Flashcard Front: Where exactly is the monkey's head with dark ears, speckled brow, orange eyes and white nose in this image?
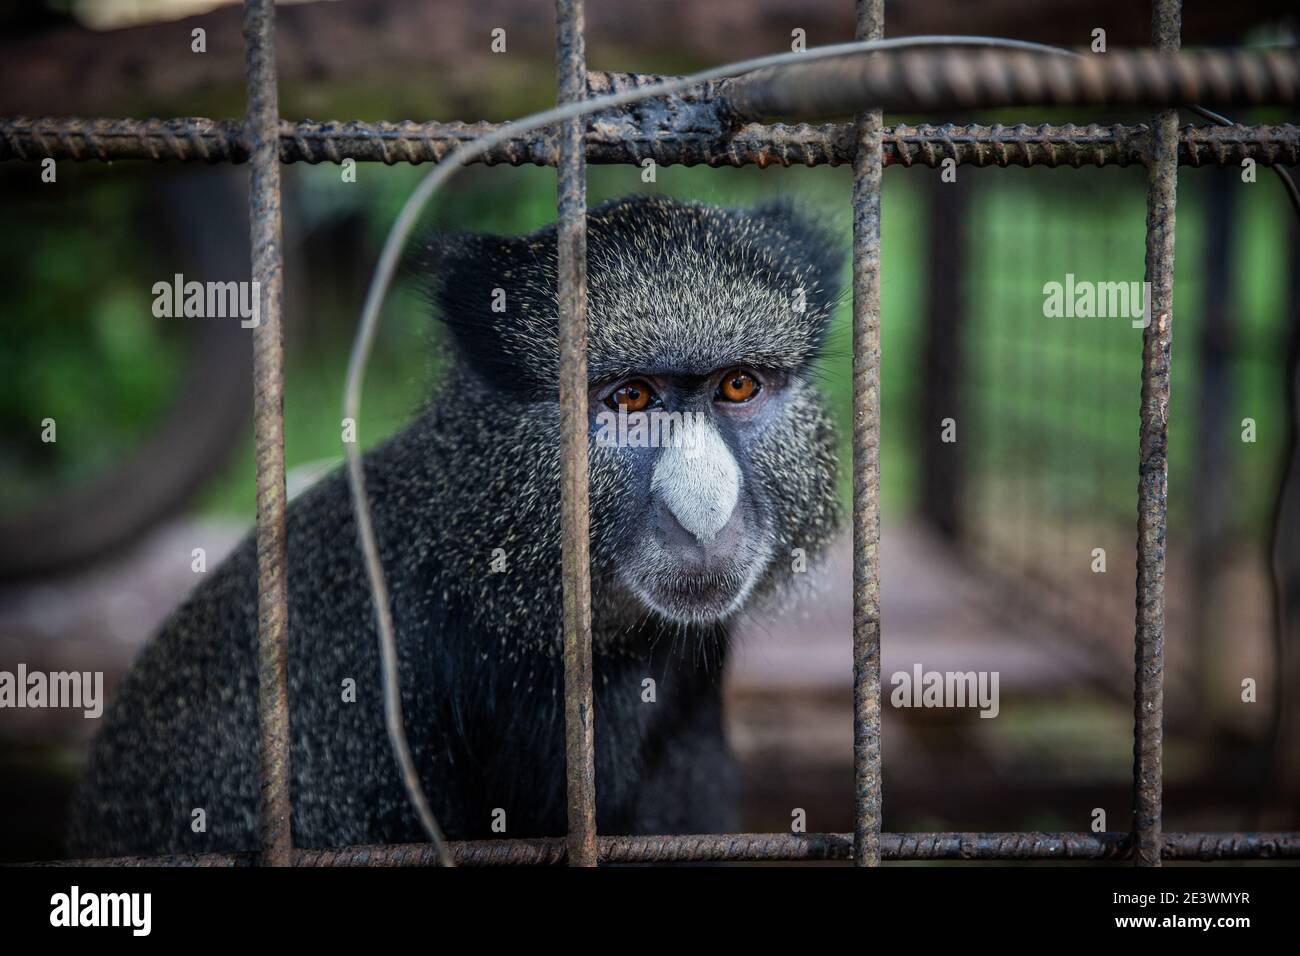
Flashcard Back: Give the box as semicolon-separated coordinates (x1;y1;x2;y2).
432;196;842;623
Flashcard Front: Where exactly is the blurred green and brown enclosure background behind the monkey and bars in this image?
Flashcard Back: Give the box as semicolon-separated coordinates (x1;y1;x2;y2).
0;0;1300;861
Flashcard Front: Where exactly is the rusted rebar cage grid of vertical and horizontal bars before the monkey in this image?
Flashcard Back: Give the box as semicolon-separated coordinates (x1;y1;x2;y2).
10;0;1300;866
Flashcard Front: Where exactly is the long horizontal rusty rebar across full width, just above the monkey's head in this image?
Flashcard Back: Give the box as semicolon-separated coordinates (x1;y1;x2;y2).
0;115;1300;168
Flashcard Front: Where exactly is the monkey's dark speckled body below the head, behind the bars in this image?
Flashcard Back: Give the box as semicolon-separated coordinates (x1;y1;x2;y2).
73;395;731;856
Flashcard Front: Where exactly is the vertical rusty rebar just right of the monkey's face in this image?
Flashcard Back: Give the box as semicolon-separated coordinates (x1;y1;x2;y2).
853;0;884;866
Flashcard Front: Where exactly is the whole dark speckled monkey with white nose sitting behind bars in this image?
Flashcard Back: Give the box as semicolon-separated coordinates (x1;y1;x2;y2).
68;195;844;858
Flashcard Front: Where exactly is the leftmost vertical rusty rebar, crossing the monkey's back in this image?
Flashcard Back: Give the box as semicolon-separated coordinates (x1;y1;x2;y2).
243;0;293;866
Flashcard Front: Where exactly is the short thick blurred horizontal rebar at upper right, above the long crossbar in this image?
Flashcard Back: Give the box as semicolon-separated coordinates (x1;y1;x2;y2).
723;46;1300;120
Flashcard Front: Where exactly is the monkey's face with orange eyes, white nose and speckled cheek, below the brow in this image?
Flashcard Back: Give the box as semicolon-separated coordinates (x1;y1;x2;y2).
589;364;835;623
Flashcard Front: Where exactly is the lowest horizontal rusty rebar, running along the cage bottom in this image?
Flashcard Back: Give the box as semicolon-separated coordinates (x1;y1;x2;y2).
38;832;1300;866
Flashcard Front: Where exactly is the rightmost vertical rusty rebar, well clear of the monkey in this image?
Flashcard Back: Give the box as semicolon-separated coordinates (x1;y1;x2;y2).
1134;0;1182;866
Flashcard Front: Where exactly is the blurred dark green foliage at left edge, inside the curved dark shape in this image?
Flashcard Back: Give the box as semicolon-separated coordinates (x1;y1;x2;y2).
0;174;181;511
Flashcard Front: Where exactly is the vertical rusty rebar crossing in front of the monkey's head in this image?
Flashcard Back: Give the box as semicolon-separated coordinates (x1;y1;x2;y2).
555;0;595;866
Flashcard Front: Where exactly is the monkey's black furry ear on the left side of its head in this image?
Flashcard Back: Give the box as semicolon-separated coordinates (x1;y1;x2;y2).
415;228;556;393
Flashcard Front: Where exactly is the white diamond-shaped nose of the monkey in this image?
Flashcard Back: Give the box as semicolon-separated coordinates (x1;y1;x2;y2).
650;414;740;544
